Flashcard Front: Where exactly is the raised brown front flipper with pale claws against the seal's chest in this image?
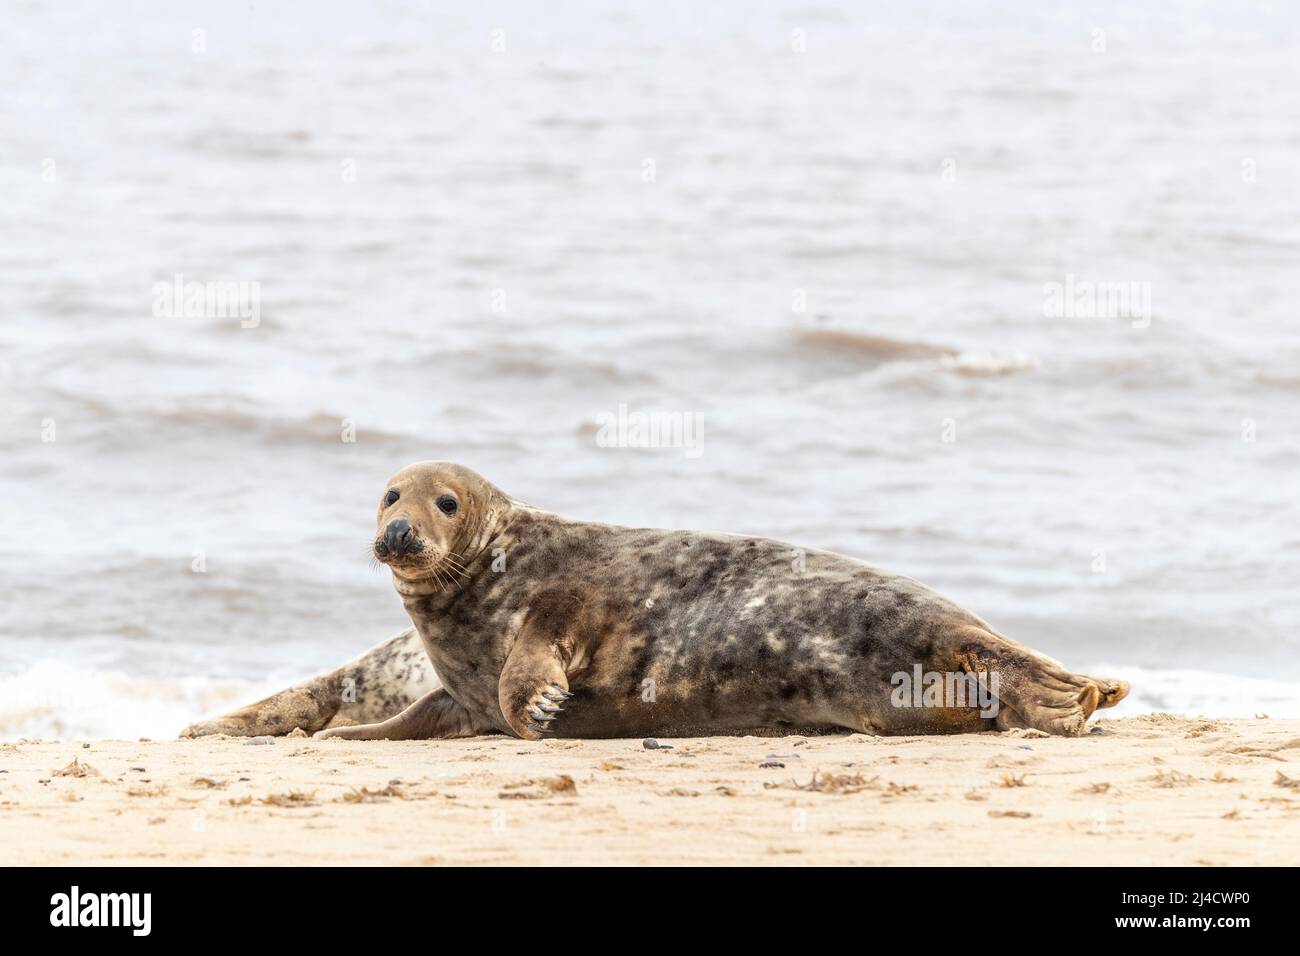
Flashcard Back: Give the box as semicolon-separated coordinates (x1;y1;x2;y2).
497;592;582;740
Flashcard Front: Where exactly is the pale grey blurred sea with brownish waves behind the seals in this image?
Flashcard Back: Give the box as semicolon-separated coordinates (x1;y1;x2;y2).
0;0;1300;739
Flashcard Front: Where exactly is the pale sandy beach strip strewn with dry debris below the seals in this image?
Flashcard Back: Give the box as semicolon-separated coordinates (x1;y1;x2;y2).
0;714;1300;866
